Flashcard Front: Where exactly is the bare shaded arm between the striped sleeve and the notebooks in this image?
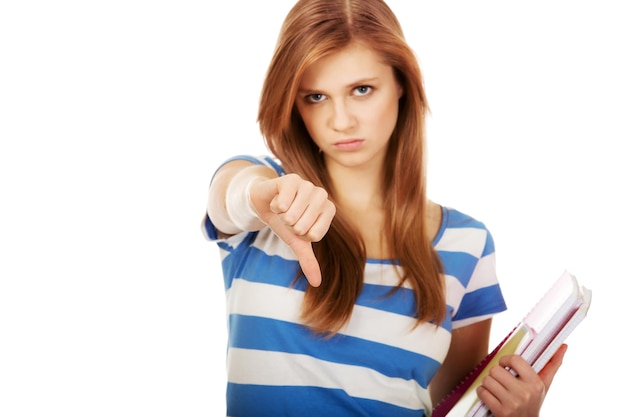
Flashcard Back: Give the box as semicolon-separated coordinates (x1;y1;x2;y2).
430;319;491;405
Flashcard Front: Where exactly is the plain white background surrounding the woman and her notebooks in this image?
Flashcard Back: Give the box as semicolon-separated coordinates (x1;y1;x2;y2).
0;0;626;417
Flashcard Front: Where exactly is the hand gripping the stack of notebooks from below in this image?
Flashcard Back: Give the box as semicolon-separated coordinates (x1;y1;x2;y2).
476;344;567;417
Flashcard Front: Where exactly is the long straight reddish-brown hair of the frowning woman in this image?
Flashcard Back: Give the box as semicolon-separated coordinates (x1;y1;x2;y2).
258;0;445;334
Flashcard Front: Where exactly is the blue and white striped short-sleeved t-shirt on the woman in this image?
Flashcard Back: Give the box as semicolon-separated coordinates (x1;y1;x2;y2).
203;157;506;417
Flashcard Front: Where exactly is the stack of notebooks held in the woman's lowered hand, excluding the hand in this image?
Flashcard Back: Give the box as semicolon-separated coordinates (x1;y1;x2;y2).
431;271;591;417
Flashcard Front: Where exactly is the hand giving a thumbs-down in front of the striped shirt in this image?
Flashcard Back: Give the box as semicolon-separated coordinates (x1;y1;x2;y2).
250;174;336;287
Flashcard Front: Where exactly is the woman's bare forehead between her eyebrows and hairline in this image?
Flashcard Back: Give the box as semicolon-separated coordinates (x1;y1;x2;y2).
300;42;393;89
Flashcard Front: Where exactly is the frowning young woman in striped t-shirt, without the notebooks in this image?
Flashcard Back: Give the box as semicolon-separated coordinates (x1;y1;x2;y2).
203;0;565;417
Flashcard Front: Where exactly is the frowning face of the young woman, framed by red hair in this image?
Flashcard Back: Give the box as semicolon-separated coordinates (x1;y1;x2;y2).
296;43;403;169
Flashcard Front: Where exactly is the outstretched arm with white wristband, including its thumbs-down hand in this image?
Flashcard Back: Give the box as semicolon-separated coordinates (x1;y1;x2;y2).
207;161;335;287
